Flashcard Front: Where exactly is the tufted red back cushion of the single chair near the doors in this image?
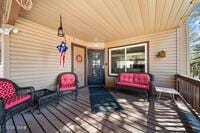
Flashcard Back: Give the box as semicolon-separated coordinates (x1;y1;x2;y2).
60;74;76;87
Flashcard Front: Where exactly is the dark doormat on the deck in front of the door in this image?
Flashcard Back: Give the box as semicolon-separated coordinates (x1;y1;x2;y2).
89;87;123;113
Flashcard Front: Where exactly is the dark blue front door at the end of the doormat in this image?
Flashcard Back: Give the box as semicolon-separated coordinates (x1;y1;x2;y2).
88;49;105;85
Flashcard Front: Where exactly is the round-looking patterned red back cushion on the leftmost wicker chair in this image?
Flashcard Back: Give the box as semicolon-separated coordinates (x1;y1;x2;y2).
0;81;15;100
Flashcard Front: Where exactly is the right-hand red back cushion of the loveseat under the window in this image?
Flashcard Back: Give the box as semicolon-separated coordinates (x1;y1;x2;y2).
133;74;150;85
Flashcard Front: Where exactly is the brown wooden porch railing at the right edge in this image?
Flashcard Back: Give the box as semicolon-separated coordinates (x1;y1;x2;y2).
176;75;200;116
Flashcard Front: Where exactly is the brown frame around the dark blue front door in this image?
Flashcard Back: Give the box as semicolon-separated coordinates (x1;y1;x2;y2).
87;48;106;86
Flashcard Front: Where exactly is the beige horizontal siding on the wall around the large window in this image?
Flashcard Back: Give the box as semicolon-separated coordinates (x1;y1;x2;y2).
105;30;177;87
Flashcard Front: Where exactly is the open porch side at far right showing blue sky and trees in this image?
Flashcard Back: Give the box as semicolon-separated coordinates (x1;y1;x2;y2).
188;4;200;79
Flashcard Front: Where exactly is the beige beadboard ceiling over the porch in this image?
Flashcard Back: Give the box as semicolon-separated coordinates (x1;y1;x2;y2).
20;0;192;42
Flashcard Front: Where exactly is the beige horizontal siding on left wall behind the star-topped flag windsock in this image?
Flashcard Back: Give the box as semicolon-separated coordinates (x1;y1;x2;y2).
9;18;87;90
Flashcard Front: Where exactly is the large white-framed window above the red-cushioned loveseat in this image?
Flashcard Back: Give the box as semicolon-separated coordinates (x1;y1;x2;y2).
108;42;148;76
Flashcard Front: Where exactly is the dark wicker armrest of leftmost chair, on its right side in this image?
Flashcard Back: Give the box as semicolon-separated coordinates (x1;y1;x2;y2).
17;86;35;99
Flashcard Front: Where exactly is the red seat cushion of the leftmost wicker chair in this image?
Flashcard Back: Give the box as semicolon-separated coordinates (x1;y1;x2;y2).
5;95;31;110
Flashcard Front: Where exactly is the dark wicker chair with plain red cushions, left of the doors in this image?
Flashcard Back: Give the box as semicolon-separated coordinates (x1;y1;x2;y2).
56;72;79;100
